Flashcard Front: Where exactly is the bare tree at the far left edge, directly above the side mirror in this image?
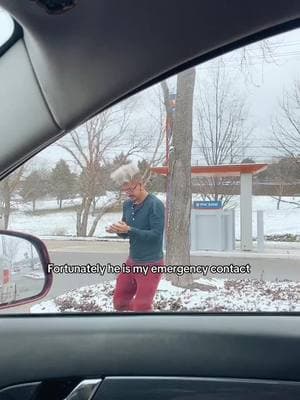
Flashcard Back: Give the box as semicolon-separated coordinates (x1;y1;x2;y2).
0;165;25;229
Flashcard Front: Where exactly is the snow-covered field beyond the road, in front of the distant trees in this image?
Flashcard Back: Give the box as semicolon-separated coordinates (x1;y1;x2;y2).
9;192;300;239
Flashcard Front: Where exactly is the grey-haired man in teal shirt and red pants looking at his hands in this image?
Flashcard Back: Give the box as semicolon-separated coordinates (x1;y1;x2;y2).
106;164;165;312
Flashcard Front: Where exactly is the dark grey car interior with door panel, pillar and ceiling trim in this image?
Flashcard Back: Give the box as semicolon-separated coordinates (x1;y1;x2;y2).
0;0;300;400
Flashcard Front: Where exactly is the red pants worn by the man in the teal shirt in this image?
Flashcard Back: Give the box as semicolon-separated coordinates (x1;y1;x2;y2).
113;257;164;312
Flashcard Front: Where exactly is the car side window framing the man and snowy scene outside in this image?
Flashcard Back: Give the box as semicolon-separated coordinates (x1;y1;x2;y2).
0;26;300;313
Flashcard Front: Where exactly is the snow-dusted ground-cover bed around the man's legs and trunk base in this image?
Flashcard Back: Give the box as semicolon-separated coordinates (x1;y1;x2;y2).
31;278;300;313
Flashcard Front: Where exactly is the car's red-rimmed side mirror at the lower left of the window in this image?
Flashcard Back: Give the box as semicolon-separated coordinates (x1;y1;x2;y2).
0;230;53;310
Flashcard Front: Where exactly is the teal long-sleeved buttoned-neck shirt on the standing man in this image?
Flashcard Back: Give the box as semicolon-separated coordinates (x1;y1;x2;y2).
119;193;165;262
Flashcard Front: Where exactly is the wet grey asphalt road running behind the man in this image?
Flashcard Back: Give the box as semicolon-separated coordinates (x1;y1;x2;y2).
2;241;300;313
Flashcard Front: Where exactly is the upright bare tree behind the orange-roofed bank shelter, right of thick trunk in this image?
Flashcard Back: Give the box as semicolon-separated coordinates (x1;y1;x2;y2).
194;58;251;204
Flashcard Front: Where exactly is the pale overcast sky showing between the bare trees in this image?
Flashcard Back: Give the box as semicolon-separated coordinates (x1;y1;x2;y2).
0;7;300;167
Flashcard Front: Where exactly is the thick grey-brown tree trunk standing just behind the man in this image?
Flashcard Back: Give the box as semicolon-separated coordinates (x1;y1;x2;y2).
166;68;196;287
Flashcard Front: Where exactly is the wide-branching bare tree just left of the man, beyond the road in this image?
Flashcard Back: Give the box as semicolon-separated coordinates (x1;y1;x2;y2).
58;102;142;236
